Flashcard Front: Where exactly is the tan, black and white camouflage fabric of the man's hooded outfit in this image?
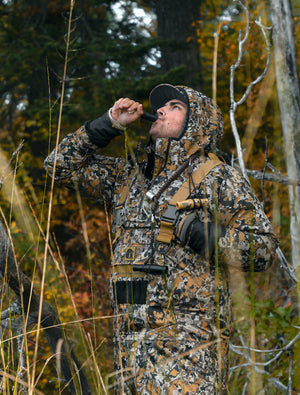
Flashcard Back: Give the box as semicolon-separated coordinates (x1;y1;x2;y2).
46;87;277;395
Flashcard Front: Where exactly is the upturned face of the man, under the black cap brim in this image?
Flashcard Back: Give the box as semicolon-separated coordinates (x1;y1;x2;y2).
149;99;187;141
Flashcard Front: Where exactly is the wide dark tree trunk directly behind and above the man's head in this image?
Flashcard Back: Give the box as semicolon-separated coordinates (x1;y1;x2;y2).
154;0;202;89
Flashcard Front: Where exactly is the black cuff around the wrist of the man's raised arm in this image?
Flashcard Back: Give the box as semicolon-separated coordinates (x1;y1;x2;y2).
84;113;122;148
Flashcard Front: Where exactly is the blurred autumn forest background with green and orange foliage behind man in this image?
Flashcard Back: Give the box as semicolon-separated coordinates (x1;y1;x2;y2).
0;0;300;394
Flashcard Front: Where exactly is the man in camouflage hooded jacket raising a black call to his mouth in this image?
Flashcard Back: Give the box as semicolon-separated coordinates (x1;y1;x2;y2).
45;84;277;395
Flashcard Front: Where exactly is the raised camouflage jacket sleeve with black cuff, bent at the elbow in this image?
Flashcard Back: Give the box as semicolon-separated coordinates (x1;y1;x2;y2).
44;114;124;203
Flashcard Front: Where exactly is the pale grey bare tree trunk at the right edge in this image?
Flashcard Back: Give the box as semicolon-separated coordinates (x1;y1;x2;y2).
271;0;300;269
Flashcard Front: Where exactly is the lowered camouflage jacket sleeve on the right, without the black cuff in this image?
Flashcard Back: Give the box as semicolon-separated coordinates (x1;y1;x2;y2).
217;168;278;272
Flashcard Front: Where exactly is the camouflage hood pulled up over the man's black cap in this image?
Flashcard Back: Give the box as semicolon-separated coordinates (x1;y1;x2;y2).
151;86;224;170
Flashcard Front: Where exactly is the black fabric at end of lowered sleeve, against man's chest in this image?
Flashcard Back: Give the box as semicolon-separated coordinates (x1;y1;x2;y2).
180;217;226;258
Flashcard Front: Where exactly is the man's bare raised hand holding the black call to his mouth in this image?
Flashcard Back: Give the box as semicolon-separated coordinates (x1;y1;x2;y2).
111;97;143;126
